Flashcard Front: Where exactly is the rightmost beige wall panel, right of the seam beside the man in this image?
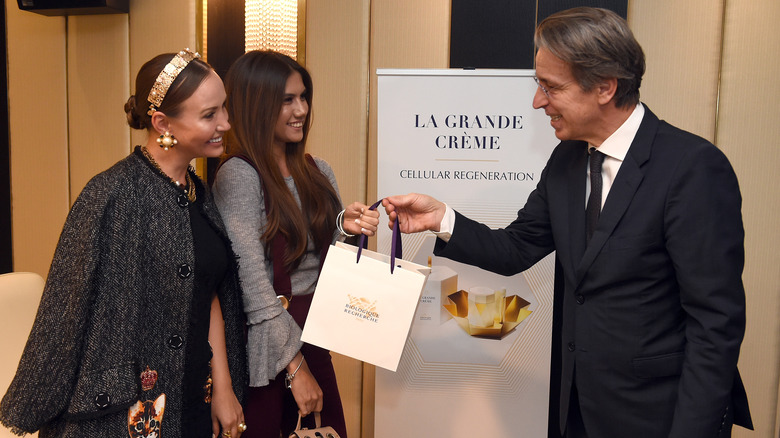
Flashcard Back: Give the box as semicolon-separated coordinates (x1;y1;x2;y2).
716;0;780;438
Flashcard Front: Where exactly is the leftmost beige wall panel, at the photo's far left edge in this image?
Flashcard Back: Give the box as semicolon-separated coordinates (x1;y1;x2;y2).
5;2;70;277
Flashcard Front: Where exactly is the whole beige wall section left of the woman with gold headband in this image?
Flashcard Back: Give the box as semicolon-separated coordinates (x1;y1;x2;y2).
5;0;201;277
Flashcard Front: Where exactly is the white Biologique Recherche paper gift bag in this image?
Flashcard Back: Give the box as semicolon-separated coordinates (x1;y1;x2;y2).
301;207;430;371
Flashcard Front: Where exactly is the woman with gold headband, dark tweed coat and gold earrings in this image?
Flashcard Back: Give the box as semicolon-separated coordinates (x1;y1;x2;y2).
0;50;247;438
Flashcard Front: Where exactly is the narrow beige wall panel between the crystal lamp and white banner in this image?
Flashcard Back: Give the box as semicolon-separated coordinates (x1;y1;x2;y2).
305;0;373;437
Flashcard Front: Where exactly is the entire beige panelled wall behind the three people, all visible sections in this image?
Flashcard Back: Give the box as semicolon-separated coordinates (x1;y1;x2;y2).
6;0;780;438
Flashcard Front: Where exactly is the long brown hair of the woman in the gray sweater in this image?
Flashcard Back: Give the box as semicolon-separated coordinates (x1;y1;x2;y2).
225;51;341;269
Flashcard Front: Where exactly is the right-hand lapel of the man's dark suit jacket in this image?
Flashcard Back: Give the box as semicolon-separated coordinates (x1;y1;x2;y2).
572;107;658;286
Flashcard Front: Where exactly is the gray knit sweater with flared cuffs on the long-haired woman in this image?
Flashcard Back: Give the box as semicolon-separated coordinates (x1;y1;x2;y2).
212;158;339;386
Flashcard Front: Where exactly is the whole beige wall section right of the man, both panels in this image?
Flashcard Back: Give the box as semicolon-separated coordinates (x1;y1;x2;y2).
629;0;780;438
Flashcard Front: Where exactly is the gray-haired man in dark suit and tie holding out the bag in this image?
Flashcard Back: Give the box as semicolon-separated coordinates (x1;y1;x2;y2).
385;8;752;438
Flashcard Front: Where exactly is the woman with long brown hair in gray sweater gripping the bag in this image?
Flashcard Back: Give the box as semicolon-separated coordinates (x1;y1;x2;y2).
213;51;379;438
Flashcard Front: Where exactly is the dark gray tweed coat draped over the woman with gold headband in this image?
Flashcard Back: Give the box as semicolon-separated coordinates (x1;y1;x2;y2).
0;147;248;438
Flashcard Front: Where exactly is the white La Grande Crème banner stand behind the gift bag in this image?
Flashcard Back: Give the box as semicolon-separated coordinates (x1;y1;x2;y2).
375;70;558;438
